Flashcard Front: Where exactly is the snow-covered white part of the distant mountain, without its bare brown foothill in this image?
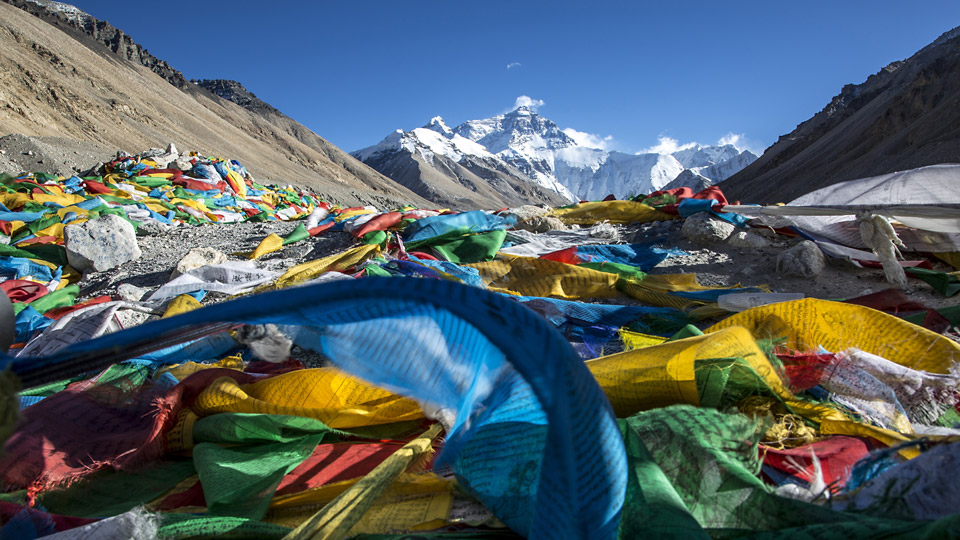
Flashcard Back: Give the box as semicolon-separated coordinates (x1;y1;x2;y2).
353;106;757;206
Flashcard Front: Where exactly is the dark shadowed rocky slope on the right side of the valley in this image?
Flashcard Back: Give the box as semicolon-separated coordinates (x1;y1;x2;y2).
722;27;960;203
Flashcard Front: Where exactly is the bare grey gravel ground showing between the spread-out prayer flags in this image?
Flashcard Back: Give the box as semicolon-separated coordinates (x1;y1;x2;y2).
71;215;956;318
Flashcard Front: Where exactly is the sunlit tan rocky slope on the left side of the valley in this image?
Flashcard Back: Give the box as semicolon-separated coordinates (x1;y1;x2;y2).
0;0;432;206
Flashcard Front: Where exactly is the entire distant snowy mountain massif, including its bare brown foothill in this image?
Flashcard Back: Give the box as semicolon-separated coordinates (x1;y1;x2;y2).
351;106;757;209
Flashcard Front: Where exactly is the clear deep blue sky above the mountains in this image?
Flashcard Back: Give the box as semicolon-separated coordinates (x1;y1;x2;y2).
75;0;960;156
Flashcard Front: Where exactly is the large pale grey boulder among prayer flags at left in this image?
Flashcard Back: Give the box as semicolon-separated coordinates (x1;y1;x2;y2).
63;214;141;272
